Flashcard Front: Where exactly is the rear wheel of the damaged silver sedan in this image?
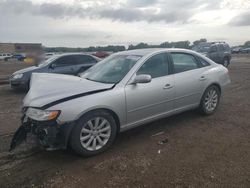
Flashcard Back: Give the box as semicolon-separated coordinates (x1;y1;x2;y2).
199;85;220;115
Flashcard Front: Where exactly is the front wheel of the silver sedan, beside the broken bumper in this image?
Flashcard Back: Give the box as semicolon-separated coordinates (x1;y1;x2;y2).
70;110;117;156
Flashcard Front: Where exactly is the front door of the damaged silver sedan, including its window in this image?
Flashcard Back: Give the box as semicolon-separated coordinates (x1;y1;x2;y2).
125;53;174;124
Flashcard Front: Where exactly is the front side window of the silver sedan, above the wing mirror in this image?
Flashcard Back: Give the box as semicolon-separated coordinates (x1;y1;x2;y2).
136;53;169;78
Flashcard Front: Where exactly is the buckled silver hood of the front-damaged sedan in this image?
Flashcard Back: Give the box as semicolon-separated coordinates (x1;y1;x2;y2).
23;73;114;107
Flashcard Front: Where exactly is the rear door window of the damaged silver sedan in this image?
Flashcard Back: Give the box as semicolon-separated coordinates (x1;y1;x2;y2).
171;53;200;73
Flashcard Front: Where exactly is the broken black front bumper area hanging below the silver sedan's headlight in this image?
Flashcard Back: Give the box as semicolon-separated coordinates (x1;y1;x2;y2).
10;115;74;151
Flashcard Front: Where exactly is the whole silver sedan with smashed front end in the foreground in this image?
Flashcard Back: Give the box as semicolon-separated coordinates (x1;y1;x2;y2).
10;49;230;156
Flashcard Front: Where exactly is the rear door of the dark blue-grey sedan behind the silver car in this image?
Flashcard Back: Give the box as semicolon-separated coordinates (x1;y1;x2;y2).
74;55;97;75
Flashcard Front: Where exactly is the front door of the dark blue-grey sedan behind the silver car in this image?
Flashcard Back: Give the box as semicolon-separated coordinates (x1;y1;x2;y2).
49;55;76;75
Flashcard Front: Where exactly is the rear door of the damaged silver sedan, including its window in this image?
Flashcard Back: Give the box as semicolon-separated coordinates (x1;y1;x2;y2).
170;52;210;110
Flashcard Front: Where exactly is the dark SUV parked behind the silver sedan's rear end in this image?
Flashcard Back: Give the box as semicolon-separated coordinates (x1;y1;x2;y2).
192;42;231;67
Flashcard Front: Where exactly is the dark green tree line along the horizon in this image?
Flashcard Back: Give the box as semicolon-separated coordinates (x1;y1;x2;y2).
44;38;250;52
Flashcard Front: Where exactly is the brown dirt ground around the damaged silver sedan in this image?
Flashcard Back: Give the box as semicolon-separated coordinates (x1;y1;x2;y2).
0;56;250;188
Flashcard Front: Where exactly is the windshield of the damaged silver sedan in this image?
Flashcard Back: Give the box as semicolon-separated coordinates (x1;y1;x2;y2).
81;55;141;84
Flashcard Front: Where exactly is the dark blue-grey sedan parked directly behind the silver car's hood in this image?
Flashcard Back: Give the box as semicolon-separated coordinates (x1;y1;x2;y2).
10;53;100;89
